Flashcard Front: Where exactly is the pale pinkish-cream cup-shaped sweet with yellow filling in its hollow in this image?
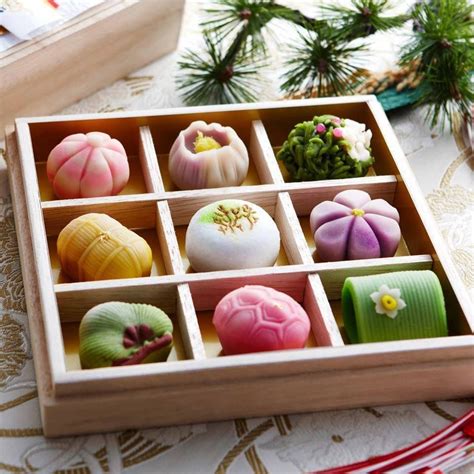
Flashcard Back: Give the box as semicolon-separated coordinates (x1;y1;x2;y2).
168;120;249;189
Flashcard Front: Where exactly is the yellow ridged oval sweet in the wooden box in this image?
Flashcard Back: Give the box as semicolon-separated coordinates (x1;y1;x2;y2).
57;213;152;281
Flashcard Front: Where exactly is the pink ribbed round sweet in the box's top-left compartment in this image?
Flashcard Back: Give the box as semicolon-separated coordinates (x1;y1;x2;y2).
46;132;130;199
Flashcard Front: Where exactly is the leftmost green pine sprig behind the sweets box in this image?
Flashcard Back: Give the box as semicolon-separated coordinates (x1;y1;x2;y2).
177;0;282;105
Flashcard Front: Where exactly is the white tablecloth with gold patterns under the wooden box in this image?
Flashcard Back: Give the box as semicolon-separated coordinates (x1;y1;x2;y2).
0;1;474;474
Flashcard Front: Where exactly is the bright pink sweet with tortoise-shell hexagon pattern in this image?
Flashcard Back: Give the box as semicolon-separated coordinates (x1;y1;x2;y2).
212;285;310;355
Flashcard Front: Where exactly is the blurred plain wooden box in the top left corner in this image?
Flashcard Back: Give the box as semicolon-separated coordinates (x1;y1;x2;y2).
0;0;184;129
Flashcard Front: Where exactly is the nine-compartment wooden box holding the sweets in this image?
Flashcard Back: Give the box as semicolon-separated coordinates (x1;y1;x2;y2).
7;96;474;436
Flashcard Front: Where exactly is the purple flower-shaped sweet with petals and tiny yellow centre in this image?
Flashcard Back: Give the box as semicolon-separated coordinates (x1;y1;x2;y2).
310;189;401;262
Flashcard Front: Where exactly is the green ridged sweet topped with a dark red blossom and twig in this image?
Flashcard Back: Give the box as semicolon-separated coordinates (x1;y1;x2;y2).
79;301;173;369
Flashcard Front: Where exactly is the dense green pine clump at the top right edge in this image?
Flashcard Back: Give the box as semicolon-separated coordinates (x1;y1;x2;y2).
401;0;474;127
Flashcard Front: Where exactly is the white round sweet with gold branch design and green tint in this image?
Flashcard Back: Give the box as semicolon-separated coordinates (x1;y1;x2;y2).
186;199;280;272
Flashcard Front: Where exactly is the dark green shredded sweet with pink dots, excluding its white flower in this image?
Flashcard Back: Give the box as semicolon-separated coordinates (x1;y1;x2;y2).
277;115;375;181
